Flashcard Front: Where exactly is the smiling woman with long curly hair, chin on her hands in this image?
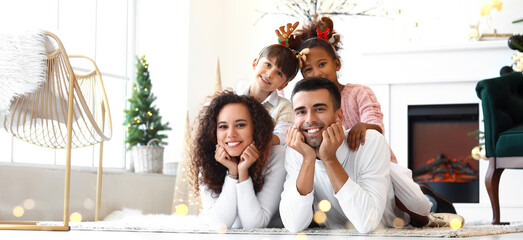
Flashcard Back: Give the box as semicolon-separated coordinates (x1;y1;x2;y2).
189;91;285;228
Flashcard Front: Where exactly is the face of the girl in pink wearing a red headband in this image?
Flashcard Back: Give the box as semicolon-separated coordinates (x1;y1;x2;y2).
301;47;341;83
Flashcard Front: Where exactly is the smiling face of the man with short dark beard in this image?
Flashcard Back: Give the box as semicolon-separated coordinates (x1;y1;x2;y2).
292;89;342;148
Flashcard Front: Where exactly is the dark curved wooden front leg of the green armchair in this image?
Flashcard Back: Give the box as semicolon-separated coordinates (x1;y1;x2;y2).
485;157;505;225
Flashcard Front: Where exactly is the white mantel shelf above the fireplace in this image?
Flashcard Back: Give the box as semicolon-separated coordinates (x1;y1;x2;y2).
341;40;514;85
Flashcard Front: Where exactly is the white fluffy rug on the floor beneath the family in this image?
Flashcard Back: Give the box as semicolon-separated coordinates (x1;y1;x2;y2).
40;209;523;238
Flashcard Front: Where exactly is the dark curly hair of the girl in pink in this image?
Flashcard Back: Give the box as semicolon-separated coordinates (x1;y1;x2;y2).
289;17;341;62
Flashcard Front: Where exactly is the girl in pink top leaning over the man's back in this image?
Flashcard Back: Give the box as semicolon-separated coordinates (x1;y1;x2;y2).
294;17;461;226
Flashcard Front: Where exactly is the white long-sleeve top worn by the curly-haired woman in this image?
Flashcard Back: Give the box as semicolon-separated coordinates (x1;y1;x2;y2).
200;145;285;229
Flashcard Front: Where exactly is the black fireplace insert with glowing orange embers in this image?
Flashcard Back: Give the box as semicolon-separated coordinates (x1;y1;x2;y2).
408;104;479;203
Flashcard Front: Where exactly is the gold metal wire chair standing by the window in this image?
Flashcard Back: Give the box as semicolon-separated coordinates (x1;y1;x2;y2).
0;32;112;231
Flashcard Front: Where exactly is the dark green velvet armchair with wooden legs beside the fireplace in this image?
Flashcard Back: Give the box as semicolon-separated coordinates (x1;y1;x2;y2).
476;72;523;224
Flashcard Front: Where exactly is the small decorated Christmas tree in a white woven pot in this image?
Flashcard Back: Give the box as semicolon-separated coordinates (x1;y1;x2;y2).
124;55;171;173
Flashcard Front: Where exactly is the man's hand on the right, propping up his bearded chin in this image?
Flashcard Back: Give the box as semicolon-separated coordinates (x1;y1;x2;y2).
318;121;345;162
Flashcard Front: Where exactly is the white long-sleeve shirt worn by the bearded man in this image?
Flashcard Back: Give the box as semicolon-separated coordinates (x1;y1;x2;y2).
280;130;409;233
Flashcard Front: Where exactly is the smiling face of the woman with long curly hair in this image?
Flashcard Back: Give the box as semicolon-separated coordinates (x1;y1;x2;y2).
216;103;254;157
